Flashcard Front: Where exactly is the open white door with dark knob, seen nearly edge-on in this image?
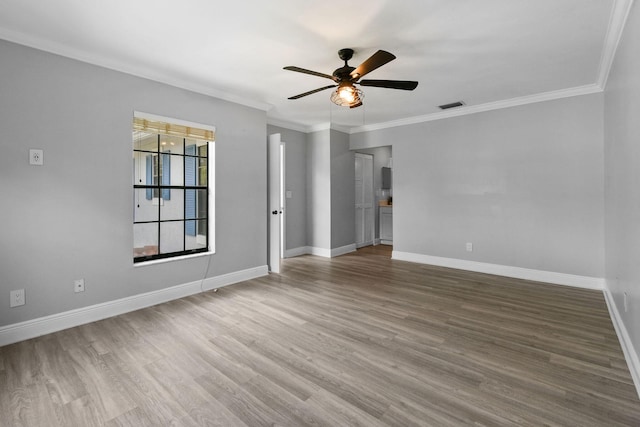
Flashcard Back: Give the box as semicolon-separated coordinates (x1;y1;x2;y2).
267;133;282;273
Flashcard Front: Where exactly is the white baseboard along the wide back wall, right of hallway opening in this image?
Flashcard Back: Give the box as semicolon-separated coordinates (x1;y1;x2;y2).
391;251;605;290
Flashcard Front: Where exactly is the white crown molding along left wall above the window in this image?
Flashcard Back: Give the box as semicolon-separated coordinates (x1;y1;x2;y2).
0;28;272;111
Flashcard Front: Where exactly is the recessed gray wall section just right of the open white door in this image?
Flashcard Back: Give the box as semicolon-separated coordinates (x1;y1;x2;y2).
267;125;307;250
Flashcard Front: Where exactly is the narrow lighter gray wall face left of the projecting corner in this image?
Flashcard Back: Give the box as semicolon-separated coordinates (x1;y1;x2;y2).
307;130;332;250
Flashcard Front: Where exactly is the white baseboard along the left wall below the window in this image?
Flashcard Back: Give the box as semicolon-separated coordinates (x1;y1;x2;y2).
0;265;269;347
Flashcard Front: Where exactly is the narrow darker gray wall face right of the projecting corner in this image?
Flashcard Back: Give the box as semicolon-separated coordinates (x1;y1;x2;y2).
330;130;356;249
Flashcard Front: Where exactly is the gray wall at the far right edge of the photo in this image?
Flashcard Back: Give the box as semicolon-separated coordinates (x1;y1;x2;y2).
604;4;640;364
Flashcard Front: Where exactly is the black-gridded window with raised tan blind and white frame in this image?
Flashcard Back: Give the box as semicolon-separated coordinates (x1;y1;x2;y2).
132;113;215;262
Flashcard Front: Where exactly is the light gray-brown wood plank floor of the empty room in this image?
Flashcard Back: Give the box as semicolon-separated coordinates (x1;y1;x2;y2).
0;246;640;427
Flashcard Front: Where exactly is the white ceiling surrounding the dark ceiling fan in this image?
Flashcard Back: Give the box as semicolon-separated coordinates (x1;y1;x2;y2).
0;0;631;129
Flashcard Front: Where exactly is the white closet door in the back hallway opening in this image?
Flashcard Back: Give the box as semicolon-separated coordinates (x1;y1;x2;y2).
355;153;375;248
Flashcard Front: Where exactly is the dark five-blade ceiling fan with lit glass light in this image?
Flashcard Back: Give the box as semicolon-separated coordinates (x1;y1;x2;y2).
284;48;418;108
